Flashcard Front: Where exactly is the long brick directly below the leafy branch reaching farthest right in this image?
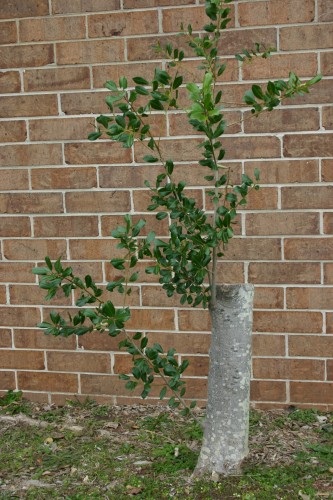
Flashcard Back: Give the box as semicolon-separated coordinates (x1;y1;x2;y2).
244;108;320;133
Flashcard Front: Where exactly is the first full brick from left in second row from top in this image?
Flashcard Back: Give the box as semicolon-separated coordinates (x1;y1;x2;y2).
19;16;86;42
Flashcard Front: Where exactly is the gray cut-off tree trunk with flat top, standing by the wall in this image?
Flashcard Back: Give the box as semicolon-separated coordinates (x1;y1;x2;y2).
194;284;253;475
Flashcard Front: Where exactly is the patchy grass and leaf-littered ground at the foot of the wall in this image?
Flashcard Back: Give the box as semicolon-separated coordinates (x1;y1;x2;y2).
0;391;333;500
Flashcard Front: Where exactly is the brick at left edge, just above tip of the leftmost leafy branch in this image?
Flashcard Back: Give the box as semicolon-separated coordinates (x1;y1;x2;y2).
3;240;66;261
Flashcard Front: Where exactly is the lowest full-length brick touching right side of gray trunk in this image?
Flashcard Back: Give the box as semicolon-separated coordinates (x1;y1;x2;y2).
253;358;325;380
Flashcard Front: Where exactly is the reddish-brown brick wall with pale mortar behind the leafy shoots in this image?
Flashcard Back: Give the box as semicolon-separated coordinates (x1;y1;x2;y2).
0;0;333;408
